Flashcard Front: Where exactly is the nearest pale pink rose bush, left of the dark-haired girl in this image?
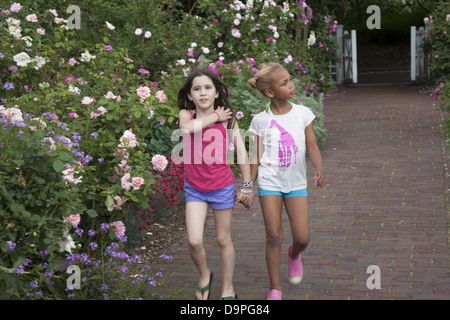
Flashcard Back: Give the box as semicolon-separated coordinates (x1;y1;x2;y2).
0;3;174;297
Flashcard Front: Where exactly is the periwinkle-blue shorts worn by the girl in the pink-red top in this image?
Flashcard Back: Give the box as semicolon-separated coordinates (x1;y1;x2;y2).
184;181;236;209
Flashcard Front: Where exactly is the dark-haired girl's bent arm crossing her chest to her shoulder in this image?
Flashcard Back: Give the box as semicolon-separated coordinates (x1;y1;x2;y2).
178;107;232;133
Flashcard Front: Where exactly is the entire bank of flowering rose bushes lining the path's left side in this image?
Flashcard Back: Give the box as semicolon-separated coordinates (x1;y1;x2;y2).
0;0;335;299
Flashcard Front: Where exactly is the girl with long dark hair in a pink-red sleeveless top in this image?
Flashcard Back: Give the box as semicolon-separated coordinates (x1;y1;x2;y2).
178;69;253;300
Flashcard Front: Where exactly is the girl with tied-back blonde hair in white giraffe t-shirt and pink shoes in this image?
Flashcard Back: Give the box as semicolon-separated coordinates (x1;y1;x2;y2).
248;63;325;300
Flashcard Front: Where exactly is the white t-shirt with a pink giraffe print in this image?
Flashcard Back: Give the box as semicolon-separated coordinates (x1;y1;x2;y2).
249;104;315;193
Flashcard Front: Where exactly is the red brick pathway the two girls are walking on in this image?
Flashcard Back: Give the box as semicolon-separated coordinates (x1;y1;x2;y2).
163;85;450;300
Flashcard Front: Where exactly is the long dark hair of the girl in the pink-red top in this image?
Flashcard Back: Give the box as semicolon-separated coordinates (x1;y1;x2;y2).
178;68;236;129
